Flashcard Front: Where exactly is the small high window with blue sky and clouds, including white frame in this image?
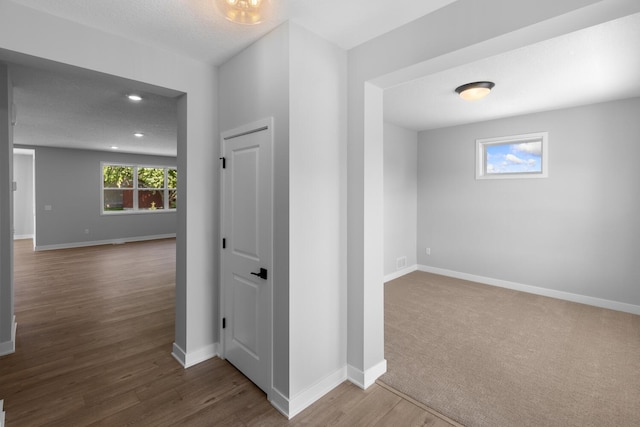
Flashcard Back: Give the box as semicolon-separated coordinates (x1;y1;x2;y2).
476;132;549;179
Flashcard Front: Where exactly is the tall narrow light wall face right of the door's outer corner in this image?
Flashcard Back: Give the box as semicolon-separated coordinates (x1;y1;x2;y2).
289;24;347;404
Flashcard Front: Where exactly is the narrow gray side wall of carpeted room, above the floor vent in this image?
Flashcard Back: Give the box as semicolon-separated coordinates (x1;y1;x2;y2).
384;122;418;277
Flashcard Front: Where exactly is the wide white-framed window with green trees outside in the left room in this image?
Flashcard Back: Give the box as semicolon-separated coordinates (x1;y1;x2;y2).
100;162;178;214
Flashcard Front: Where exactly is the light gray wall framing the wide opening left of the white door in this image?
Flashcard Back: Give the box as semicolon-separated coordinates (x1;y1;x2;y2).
0;0;219;364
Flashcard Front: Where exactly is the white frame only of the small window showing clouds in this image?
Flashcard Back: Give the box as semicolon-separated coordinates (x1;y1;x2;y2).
476;132;549;180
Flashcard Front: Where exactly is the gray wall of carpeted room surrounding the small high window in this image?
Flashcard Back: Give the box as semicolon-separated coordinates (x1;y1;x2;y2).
418;98;640;305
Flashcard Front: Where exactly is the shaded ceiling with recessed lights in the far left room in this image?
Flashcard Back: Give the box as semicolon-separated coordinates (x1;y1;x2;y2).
11;65;177;156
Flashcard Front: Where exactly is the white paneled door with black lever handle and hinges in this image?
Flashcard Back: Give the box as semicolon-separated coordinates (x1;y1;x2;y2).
221;119;273;392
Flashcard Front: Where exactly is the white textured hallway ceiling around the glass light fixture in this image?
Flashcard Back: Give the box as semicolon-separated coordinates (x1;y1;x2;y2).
7;0;455;65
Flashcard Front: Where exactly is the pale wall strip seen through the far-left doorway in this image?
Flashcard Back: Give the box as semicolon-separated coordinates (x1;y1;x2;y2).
13;154;34;238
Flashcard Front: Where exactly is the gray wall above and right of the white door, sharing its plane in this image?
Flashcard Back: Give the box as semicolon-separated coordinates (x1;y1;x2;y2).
218;24;290;398
